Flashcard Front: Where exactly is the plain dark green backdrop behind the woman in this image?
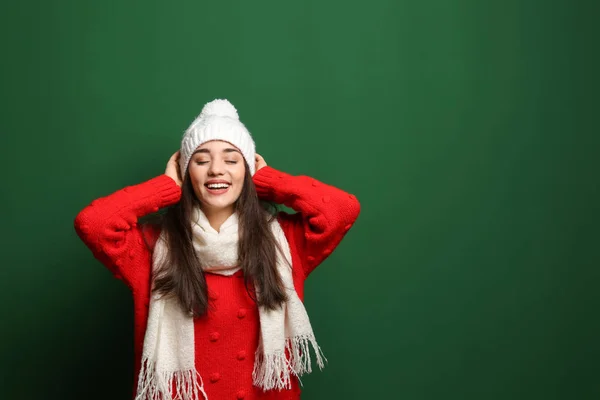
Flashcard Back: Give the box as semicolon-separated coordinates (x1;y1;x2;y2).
0;0;600;400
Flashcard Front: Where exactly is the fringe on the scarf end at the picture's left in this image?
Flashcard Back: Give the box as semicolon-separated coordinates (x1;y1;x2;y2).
135;357;208;400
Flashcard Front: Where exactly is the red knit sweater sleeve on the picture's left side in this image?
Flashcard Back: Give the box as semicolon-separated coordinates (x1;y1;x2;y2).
75;175;181;289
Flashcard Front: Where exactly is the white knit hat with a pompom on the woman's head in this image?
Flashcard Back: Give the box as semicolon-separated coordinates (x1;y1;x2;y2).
179;99;256;176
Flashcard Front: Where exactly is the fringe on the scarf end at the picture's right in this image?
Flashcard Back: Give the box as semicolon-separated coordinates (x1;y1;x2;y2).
252;335;327;390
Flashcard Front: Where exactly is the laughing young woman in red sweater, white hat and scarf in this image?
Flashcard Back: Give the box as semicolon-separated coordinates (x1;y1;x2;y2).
75;100;360;400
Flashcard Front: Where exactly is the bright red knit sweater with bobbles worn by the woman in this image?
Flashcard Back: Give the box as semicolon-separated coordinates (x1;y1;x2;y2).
75;166;360;400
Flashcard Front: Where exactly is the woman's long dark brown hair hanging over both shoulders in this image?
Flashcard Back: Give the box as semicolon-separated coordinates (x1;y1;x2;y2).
153;160;287;317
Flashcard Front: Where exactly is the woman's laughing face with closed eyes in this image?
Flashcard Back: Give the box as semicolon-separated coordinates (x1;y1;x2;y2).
188;140;246;212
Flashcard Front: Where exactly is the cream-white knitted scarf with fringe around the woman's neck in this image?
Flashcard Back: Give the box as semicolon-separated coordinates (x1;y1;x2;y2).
135;207;327;400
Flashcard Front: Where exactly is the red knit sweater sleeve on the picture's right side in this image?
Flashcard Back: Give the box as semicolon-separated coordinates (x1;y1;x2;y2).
253;166;360;277
